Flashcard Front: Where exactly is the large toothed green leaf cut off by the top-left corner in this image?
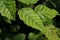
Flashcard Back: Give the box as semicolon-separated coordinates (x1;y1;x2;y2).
0;0;16;20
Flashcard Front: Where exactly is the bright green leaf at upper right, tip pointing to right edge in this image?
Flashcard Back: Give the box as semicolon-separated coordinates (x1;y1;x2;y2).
35;5;58;19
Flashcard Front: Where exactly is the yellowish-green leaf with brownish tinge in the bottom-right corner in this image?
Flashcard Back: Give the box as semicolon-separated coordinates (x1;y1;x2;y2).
44;24;60;40
